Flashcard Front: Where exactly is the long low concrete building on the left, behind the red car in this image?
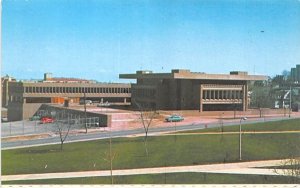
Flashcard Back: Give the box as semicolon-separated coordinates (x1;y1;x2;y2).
8;73;131;121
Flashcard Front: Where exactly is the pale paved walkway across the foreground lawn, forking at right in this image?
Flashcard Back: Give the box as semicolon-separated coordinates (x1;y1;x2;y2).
1;160;288;181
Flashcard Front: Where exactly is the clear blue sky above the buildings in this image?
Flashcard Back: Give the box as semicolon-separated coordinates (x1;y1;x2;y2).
1;0;300;82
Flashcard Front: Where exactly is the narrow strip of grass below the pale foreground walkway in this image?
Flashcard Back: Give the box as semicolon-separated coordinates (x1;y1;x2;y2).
2;173;300;184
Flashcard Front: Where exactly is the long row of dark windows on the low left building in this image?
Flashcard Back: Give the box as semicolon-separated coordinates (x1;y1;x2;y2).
24;87;131;93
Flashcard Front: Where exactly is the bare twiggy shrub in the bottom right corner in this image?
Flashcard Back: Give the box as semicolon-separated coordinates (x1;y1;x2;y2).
274;157;300;183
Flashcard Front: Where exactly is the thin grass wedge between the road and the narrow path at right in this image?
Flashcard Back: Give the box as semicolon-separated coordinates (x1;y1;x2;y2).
179;119;300;133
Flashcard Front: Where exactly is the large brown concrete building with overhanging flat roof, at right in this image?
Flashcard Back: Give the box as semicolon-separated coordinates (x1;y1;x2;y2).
119;69;267;112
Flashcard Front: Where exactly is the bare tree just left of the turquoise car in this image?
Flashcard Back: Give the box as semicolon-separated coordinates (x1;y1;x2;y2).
133;100;157;156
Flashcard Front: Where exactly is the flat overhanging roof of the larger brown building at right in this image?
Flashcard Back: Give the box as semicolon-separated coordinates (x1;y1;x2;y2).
119;69;268;81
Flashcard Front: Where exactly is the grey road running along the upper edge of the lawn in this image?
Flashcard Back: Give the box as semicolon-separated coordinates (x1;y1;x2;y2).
1;117;296;150
